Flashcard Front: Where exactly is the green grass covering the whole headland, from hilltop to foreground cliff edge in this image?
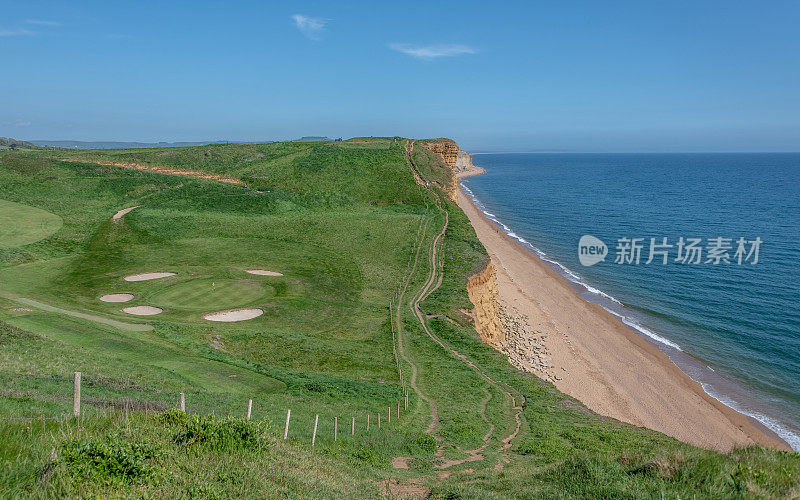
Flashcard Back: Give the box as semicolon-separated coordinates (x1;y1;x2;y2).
0;138;800;497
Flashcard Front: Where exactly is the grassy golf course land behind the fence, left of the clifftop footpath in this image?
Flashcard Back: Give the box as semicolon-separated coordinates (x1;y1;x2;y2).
0;138;427;420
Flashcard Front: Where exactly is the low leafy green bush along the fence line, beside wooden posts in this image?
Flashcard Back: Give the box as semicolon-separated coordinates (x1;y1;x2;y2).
170;412;272;450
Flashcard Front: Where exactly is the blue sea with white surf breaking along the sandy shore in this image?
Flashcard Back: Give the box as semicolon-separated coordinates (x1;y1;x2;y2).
462;153;800;451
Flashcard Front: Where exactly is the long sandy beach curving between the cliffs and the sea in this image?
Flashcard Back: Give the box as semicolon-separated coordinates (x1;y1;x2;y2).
456;165;791;451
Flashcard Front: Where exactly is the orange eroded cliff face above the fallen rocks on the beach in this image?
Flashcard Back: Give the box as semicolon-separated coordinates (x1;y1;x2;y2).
467;263;506;349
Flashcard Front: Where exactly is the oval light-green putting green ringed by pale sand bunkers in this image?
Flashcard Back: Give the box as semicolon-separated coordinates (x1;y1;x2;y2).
147;278;272;311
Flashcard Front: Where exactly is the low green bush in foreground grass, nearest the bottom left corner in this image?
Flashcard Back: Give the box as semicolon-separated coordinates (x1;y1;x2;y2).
61;435;159;482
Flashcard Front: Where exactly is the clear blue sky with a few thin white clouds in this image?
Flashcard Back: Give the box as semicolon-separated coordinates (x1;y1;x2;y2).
0;0;800;151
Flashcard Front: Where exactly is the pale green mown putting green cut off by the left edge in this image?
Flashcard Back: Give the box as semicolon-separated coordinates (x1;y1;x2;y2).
0;200;63;248
